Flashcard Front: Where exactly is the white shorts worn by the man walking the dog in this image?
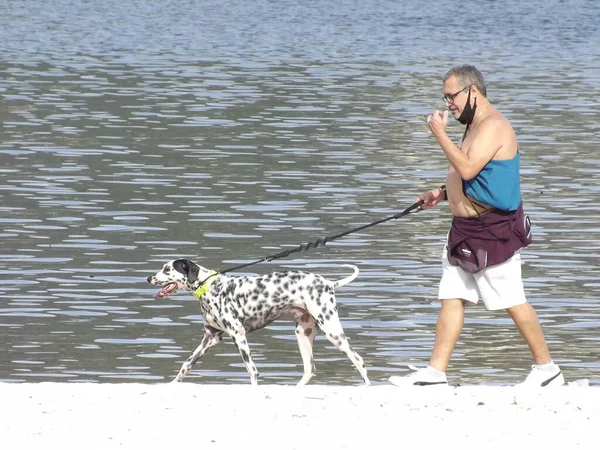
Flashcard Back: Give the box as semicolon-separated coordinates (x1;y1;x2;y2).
438;245;527;310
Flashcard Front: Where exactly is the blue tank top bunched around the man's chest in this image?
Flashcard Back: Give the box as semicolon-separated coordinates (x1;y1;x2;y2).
463;153;521;211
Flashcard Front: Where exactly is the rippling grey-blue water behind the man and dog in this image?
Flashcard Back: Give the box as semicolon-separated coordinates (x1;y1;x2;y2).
0;0;600;384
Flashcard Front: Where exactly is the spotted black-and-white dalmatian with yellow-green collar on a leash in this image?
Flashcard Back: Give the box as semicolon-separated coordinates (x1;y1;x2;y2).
147;259;370;386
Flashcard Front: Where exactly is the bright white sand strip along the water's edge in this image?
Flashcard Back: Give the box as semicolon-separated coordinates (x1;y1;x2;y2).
0;382;600;450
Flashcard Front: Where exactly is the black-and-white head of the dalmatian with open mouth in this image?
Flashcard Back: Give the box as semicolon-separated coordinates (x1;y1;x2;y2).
147;259;209;298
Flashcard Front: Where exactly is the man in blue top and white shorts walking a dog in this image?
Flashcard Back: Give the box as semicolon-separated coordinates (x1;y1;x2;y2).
389;66;564;386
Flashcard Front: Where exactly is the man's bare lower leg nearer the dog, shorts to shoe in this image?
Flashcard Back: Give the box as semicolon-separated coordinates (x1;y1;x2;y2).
429;299;465;373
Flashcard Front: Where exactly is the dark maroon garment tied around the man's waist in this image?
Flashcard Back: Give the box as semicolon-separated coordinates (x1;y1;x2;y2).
447;203;532;273
